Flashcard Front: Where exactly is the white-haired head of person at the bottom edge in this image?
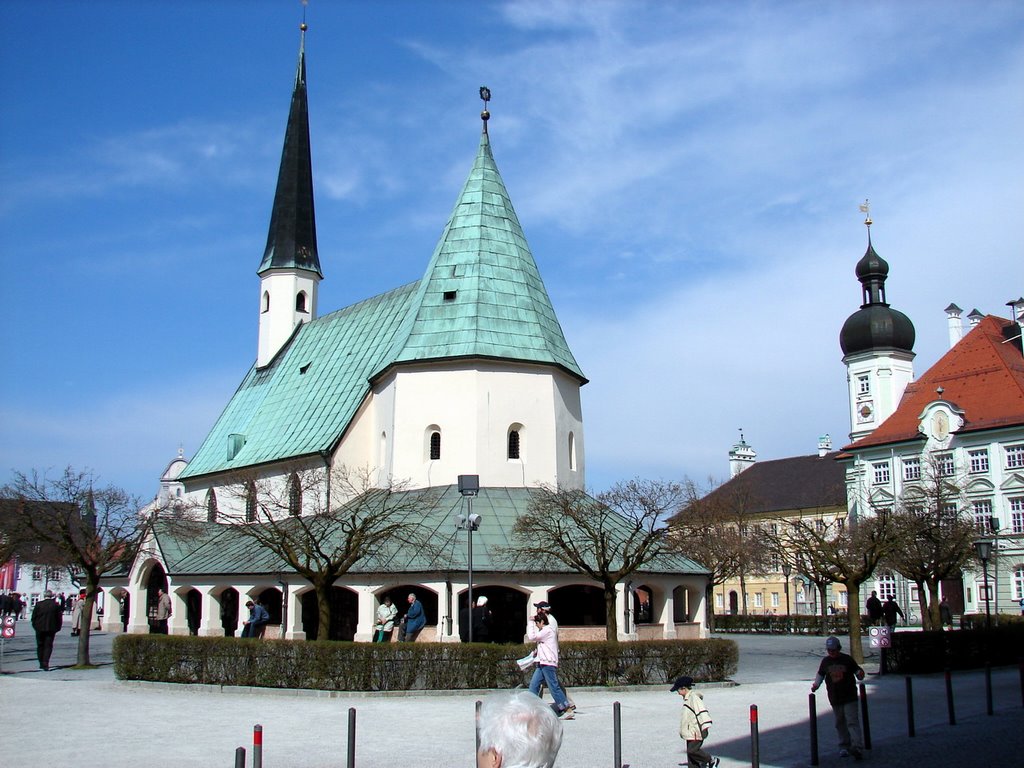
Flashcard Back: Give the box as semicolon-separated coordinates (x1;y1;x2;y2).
477;691;562;768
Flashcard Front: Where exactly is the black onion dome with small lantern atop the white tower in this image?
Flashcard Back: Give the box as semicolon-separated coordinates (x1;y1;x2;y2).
839;236;916;355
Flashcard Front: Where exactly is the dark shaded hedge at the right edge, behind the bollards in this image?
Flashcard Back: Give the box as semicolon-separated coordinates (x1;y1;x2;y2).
885;617;1024;675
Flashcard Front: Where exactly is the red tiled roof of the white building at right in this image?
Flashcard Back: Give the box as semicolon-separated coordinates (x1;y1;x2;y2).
843;314;1024;451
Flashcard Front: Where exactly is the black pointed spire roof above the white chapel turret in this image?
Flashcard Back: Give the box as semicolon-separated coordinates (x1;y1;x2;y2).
256;22;324;278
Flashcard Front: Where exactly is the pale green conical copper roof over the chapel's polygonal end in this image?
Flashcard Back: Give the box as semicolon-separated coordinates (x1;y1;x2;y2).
389;132;586;382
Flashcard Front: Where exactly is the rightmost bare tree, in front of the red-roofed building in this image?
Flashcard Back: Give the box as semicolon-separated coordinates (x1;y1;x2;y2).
883;457;974;630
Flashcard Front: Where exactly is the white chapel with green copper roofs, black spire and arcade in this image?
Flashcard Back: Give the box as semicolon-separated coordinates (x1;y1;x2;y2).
106;27;706;641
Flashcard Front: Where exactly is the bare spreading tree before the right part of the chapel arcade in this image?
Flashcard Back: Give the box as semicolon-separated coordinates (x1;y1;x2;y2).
496;479;683;642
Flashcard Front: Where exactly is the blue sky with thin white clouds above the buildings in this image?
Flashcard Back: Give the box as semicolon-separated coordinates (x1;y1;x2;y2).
0;0;1024;498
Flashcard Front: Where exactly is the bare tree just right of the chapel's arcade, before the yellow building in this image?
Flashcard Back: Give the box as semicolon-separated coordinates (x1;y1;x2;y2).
670;479;771;629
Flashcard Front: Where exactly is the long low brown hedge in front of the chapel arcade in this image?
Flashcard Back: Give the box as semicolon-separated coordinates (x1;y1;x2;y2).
114;635;739;691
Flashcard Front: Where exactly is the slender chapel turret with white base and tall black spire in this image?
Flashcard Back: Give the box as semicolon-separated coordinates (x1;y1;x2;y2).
256;22;324;368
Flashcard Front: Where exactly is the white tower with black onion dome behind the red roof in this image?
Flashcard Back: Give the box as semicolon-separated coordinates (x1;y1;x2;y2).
839;201;914;441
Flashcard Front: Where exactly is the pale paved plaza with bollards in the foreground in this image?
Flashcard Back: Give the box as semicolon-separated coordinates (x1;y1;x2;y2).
0;622;1024;768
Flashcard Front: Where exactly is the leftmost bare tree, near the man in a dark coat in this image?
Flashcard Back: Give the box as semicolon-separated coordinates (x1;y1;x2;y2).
0;467;147;667
